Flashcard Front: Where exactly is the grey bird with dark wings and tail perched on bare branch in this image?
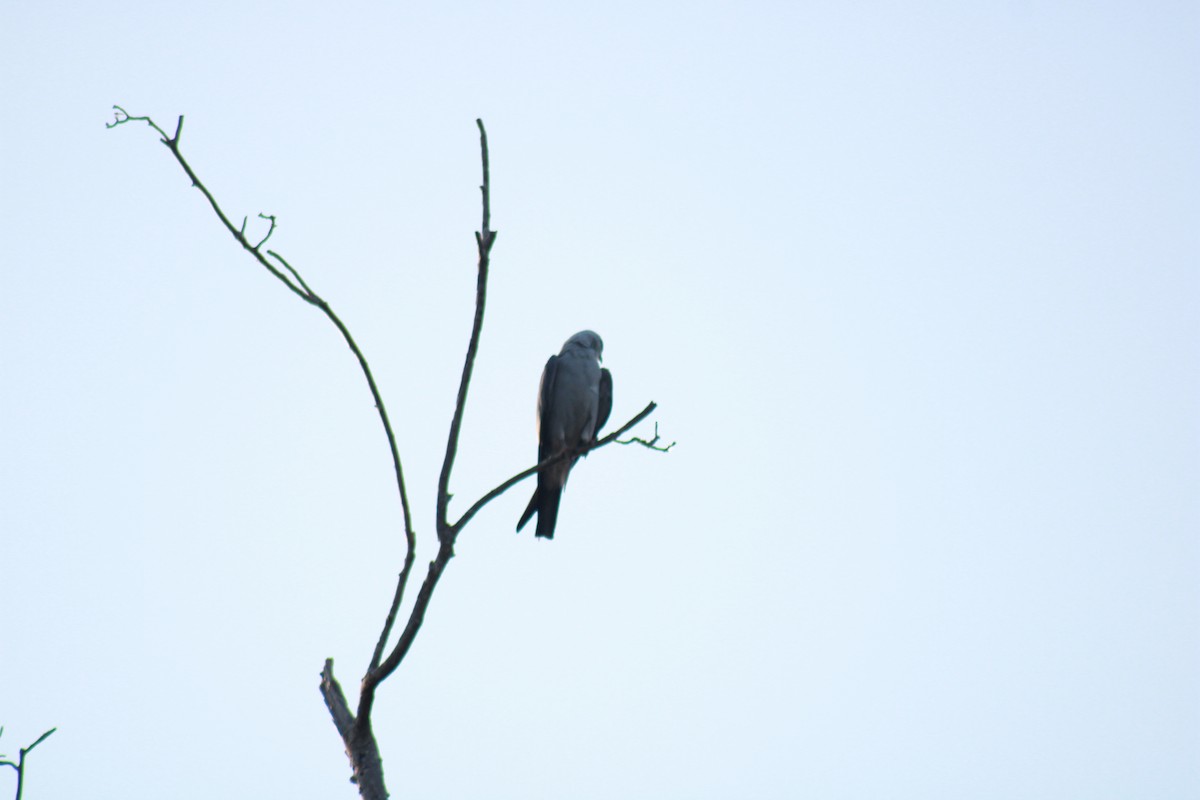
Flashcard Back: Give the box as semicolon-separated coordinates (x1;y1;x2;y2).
517;331;612;539
